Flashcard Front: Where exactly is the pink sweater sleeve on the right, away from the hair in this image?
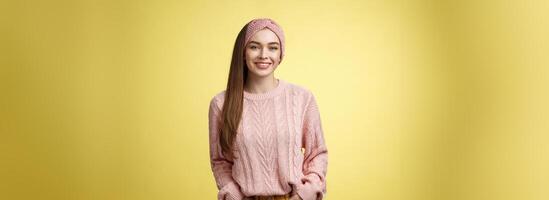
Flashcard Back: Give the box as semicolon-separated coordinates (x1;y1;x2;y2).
297;94;328;200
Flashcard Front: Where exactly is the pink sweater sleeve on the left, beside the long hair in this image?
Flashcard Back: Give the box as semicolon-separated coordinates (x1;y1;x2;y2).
208;97;244;200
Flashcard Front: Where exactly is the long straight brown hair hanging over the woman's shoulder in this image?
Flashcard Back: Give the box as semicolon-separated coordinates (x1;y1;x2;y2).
219;25;248;158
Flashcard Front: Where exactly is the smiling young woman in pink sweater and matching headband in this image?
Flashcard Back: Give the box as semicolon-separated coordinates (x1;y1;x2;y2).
209;19;328;200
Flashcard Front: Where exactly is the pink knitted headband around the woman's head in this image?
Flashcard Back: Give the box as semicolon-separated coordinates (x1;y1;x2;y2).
244;18;284;61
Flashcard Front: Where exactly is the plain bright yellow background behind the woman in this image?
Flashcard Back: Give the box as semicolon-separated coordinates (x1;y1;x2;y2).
0;0;549;200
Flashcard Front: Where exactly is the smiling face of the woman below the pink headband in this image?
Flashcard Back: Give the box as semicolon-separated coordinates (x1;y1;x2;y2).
244;29;280;77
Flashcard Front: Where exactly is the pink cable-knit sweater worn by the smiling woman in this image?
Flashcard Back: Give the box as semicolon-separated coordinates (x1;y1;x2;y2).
209;79;328;200
